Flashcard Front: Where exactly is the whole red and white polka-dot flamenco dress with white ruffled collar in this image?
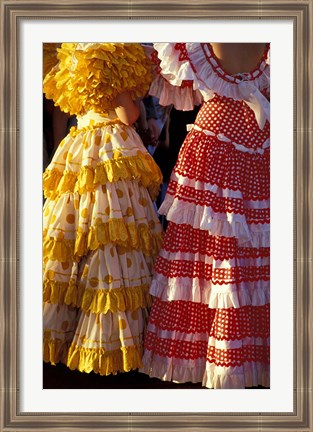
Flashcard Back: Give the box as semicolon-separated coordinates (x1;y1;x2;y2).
141;43;270;389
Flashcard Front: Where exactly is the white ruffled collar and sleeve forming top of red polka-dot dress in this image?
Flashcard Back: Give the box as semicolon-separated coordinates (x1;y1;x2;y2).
150;43;270;128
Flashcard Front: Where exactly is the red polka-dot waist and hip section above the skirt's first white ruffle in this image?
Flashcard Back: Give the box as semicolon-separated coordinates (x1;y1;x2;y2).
169;95;270;204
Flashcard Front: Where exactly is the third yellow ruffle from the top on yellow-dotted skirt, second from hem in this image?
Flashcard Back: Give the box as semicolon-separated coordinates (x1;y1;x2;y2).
43;280;152;314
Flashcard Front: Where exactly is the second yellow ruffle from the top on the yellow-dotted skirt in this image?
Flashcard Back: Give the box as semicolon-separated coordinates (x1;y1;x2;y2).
43;219;163;262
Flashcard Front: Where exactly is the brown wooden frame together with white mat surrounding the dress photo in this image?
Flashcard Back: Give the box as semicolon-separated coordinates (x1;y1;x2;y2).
0;0;313;432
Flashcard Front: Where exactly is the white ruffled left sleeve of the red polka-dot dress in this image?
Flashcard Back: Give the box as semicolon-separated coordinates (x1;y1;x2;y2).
149;43;202;111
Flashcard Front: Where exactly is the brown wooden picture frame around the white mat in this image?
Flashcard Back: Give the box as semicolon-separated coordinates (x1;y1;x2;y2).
0;0;313;432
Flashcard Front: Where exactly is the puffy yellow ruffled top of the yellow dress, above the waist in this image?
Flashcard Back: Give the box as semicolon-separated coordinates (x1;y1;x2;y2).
44;43;152;115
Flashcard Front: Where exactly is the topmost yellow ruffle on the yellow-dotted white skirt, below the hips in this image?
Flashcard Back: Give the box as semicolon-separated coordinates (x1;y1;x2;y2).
43;152;162;200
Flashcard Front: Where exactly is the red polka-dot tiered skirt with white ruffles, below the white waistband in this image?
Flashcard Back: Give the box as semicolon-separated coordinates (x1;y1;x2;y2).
141;104;270;389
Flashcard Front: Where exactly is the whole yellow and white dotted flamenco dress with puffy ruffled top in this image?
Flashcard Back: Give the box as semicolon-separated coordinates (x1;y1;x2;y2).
43;43;162;375
